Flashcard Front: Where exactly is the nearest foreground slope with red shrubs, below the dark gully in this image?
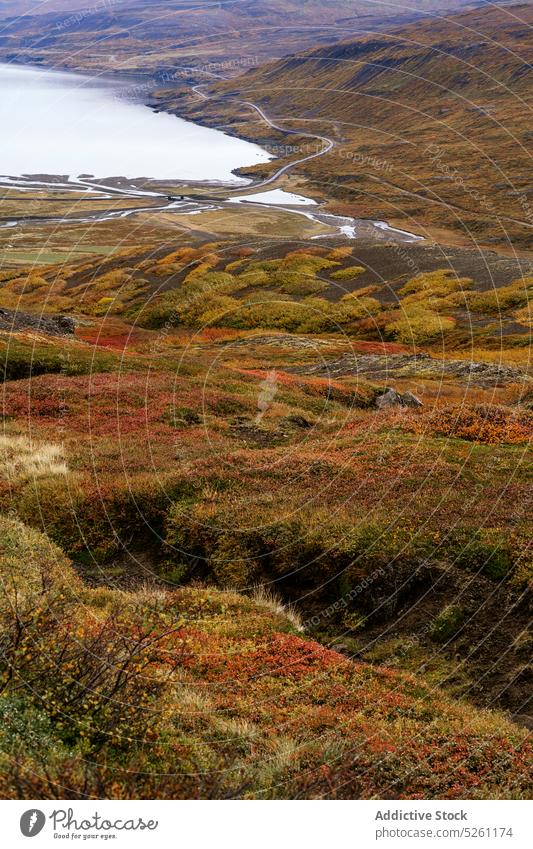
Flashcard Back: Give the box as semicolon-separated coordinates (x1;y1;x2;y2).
0;519;529;798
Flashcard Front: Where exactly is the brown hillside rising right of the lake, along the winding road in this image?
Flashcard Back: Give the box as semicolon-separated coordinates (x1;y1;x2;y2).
160;4;533;250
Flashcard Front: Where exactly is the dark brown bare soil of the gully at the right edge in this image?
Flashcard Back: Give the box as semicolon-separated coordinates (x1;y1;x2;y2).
356;567;533;725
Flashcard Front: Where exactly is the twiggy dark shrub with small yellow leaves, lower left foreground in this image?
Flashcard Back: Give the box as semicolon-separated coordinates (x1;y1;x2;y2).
4;603;181;750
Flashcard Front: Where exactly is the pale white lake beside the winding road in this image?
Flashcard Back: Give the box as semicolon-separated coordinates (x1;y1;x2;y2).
0;64;272;184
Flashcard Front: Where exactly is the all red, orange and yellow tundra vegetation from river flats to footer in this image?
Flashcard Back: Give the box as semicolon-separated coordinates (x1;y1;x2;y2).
0;235;533;799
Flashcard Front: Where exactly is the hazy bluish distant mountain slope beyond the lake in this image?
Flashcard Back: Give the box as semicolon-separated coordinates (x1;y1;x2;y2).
0;0;479;75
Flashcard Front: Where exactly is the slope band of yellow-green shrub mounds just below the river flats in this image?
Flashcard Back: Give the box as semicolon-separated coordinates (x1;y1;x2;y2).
0;239;533;352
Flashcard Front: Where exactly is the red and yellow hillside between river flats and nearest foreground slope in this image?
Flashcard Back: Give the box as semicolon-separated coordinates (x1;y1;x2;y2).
0;241;533;724
